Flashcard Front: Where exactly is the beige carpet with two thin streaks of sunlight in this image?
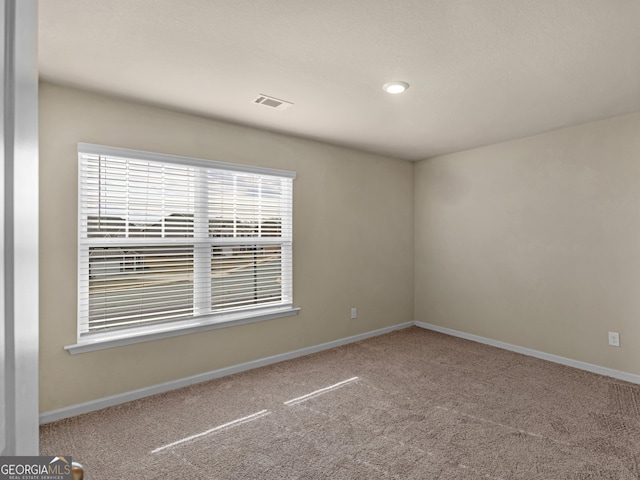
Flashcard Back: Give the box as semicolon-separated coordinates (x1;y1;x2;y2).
41;327;640;480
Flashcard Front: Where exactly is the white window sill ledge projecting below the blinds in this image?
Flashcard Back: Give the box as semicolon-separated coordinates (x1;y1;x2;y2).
64;307;300;354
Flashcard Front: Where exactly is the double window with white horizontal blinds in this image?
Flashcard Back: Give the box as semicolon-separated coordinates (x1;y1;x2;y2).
67;144;295;350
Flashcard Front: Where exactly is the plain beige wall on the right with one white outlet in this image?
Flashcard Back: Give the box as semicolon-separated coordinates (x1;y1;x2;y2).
414;114;640;374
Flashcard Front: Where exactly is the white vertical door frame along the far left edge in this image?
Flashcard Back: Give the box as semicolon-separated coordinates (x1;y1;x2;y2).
0;0;39;455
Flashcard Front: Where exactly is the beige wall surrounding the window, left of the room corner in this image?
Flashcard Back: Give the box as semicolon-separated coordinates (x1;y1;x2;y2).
40;83;413;412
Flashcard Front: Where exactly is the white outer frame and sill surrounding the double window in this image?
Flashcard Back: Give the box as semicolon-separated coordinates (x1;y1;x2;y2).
64;143;300;353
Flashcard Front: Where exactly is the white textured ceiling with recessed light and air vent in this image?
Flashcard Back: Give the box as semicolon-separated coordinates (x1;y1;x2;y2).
39;0;640;160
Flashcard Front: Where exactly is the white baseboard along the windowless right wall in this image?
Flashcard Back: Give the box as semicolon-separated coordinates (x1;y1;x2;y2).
415;322;640;384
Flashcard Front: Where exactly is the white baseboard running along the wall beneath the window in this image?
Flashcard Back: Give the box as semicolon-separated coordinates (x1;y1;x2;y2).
40;322;414;424
